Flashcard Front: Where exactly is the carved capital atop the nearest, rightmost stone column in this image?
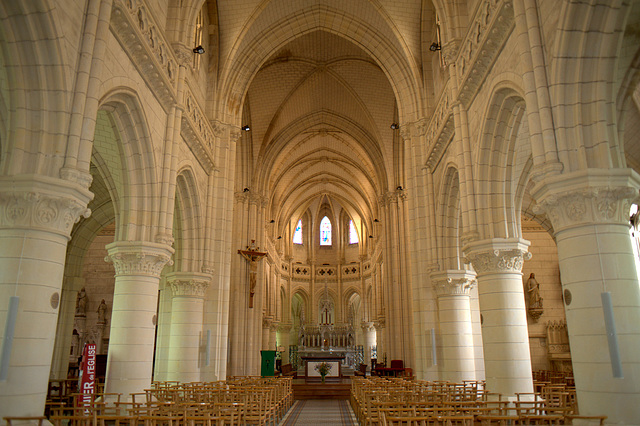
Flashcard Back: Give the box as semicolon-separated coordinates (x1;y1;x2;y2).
531;169;640;233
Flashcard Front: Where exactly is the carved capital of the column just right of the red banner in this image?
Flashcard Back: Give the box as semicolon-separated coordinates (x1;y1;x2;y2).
104;241;174;278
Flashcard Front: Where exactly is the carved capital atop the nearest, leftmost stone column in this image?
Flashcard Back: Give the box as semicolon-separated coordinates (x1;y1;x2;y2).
0;175;93;239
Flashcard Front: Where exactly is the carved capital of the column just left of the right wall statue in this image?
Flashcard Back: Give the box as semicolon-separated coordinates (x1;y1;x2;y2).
463;238;531;275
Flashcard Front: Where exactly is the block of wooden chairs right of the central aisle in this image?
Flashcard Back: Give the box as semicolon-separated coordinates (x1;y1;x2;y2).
351;378;606;426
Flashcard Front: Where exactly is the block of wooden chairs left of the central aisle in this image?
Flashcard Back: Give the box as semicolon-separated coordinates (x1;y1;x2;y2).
43;377;293;426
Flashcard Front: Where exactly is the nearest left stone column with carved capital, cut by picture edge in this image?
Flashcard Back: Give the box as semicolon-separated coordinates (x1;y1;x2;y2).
0;176;92;416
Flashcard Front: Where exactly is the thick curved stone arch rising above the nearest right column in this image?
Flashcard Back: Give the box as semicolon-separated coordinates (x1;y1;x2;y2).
550;0;638;172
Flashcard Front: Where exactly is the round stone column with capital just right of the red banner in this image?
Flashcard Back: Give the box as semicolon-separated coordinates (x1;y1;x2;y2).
105;241;173;399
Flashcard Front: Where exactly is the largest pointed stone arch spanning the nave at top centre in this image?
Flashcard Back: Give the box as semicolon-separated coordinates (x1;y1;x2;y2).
216;2;424;126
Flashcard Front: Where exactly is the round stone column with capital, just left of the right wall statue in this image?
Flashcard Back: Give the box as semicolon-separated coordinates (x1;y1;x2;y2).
463;238;533;398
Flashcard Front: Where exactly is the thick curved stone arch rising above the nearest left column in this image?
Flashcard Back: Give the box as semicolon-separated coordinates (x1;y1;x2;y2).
0;0;70;177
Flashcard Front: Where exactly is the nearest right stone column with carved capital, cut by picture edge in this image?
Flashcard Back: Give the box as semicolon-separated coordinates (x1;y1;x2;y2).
532;169;640;425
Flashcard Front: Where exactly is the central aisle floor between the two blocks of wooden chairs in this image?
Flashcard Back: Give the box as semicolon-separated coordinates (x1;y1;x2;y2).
279;399;358;426
